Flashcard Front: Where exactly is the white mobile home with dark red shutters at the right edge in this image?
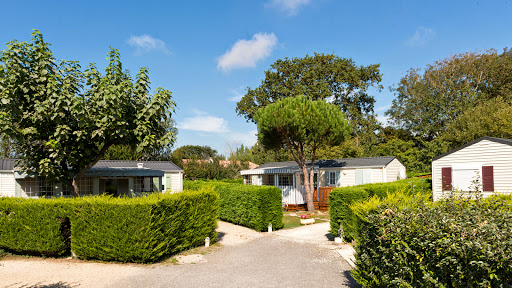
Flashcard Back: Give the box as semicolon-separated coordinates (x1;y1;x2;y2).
432;137;512;201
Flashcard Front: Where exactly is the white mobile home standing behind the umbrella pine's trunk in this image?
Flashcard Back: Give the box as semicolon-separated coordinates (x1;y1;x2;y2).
240;156;406;205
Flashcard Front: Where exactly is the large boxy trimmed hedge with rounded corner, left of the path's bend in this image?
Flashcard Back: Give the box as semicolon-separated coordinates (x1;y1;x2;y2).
71;190;218;262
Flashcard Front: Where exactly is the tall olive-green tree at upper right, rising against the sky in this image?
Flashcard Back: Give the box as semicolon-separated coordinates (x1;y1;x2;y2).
386;49;512;141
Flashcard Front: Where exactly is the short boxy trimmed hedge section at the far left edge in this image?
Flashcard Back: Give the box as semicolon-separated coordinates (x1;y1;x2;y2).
0;197;71;256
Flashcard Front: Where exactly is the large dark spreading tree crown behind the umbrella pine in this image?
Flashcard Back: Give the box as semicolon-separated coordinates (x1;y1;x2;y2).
236;53;382;150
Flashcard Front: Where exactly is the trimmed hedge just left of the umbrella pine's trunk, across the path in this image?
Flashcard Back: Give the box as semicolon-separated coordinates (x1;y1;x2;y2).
184;181;283;231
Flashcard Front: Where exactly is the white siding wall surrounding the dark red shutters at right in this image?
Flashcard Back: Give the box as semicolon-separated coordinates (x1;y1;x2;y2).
432;140;512;200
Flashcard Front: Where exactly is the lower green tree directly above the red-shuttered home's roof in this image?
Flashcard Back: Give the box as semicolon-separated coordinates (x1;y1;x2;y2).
440;97;512;148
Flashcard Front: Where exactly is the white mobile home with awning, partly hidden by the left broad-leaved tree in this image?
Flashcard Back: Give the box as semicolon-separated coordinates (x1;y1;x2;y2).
0;159;183;198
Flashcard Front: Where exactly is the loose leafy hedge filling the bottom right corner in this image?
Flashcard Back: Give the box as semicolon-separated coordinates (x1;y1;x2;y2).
353;197;512;288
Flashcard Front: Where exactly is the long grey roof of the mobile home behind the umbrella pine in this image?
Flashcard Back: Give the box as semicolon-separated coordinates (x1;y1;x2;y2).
250;156;396;169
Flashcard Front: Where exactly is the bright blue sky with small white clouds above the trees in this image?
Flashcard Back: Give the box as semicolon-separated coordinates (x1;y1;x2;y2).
0;0;512;154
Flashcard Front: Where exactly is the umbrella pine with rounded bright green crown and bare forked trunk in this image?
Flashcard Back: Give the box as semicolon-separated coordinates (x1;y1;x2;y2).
254;96;351;211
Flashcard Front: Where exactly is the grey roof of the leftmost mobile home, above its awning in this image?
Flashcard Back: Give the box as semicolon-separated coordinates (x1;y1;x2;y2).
0;158;183;172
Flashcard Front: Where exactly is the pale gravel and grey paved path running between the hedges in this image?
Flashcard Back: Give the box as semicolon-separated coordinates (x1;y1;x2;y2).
0;221;357;288
